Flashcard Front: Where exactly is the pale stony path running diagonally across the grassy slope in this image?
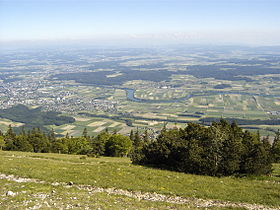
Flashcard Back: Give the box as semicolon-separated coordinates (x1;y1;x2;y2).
0;174;279;210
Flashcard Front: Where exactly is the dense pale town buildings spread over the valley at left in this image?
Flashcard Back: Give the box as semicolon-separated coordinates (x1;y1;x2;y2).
0;78;117;114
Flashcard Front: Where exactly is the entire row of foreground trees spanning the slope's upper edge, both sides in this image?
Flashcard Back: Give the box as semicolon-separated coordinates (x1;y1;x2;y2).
0;119;280;176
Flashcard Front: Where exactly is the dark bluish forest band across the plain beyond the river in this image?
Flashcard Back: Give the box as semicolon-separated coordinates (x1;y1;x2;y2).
50;59;280;86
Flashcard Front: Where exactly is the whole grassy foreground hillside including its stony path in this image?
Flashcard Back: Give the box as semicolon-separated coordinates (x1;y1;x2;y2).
0;151;280;209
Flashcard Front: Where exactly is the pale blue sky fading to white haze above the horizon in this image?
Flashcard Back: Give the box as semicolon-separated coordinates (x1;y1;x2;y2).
0;0;280;45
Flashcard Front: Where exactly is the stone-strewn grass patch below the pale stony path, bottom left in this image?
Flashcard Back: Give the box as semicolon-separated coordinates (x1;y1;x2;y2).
0;180;220;209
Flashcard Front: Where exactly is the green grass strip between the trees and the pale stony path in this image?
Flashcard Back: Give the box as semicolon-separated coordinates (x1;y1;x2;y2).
0;151;280;206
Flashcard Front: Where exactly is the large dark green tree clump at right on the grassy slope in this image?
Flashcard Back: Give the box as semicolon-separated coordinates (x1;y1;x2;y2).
131;119;280;176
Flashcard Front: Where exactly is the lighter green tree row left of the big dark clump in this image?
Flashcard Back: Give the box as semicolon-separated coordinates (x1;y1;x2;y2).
0;126;132;157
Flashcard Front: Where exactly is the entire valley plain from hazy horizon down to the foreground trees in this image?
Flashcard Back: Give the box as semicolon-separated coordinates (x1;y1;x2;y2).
0;46;280;136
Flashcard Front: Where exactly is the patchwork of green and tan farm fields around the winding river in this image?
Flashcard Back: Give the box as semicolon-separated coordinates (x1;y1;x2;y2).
0;75;280;136
